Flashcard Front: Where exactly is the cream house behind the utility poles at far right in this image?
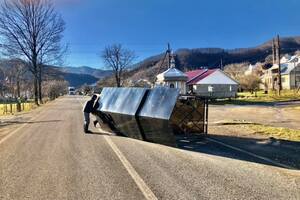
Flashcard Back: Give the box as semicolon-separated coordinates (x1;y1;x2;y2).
261;55;300;90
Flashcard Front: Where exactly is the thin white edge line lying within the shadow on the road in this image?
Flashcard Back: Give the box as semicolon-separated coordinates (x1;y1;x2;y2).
206;138;296;170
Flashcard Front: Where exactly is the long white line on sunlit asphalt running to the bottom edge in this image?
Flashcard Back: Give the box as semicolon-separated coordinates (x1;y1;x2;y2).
79;101;158;200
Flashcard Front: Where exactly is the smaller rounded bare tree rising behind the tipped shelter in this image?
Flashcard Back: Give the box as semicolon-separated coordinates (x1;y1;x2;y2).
101;44;136;87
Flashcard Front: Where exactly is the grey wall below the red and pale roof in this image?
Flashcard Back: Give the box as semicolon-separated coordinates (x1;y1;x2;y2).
193;84;238;98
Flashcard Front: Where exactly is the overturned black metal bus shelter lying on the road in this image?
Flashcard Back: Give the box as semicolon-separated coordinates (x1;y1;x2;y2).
97;87;208;146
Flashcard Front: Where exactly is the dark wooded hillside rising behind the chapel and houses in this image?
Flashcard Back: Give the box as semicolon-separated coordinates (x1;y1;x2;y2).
120;36;300;81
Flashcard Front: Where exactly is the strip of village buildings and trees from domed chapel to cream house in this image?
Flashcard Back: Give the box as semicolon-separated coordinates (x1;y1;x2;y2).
147;39;300;98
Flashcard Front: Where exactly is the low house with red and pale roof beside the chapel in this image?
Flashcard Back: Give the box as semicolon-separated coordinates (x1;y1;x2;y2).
186;69;239;98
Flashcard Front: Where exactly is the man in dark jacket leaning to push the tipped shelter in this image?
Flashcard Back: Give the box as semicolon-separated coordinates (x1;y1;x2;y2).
83;94;99;133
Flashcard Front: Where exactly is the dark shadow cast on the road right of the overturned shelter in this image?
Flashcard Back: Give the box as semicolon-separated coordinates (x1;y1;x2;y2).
177;135;300;169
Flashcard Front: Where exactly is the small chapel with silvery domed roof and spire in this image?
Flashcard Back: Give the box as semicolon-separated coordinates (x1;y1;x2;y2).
155;51;188;94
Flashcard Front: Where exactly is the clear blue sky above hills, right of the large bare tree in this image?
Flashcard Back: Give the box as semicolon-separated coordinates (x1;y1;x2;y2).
56;0;300;68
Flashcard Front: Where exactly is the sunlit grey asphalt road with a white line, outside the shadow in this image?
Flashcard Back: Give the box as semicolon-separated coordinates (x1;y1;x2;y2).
0;97;300;200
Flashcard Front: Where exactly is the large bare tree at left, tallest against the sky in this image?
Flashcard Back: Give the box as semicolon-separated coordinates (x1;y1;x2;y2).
0;0;65;105
